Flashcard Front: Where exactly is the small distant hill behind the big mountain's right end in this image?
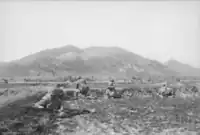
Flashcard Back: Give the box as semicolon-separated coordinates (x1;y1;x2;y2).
165;60;200;76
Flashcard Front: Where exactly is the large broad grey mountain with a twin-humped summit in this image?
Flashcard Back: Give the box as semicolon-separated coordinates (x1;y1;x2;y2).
0;45;187;77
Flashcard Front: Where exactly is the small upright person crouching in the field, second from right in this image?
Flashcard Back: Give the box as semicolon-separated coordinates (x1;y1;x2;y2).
106;79;116;98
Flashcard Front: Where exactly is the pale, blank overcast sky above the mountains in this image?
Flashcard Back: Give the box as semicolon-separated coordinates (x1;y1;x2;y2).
0;0;200;67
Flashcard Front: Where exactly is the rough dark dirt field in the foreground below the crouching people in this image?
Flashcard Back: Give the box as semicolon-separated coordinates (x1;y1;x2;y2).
0;87;200;135
